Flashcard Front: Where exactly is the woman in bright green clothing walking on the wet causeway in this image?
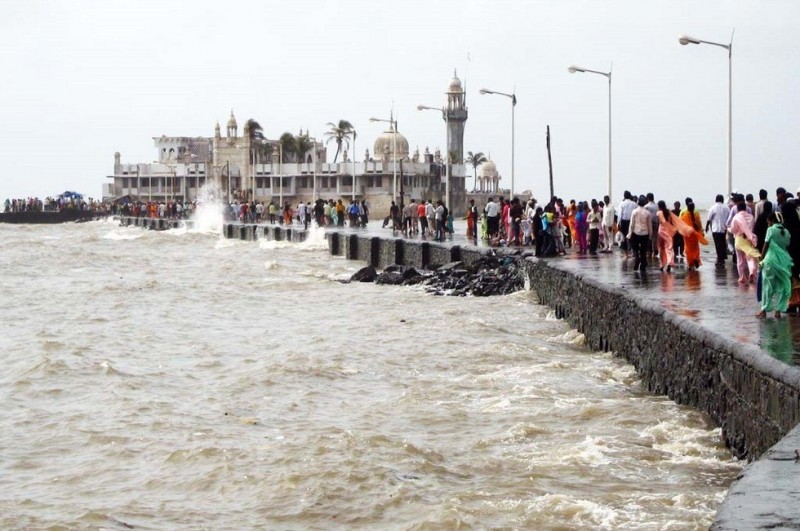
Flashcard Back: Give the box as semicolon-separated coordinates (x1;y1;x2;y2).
756;212;793;318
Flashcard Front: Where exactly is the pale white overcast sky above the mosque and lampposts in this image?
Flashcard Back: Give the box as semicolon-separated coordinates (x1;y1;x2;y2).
0;0;800;203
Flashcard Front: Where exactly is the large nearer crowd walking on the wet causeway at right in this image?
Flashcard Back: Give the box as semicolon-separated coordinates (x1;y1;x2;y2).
467;188;800;317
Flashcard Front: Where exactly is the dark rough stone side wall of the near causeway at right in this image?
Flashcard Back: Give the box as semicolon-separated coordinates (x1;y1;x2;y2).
524;258;800;459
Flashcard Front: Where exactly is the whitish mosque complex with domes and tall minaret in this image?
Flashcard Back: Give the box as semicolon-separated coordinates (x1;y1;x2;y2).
103;74;510;217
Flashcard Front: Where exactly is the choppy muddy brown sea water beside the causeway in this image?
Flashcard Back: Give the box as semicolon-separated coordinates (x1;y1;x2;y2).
0;222;741;529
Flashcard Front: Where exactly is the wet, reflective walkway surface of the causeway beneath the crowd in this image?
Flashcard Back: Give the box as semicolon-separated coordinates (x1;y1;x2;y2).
322;221;800;365
